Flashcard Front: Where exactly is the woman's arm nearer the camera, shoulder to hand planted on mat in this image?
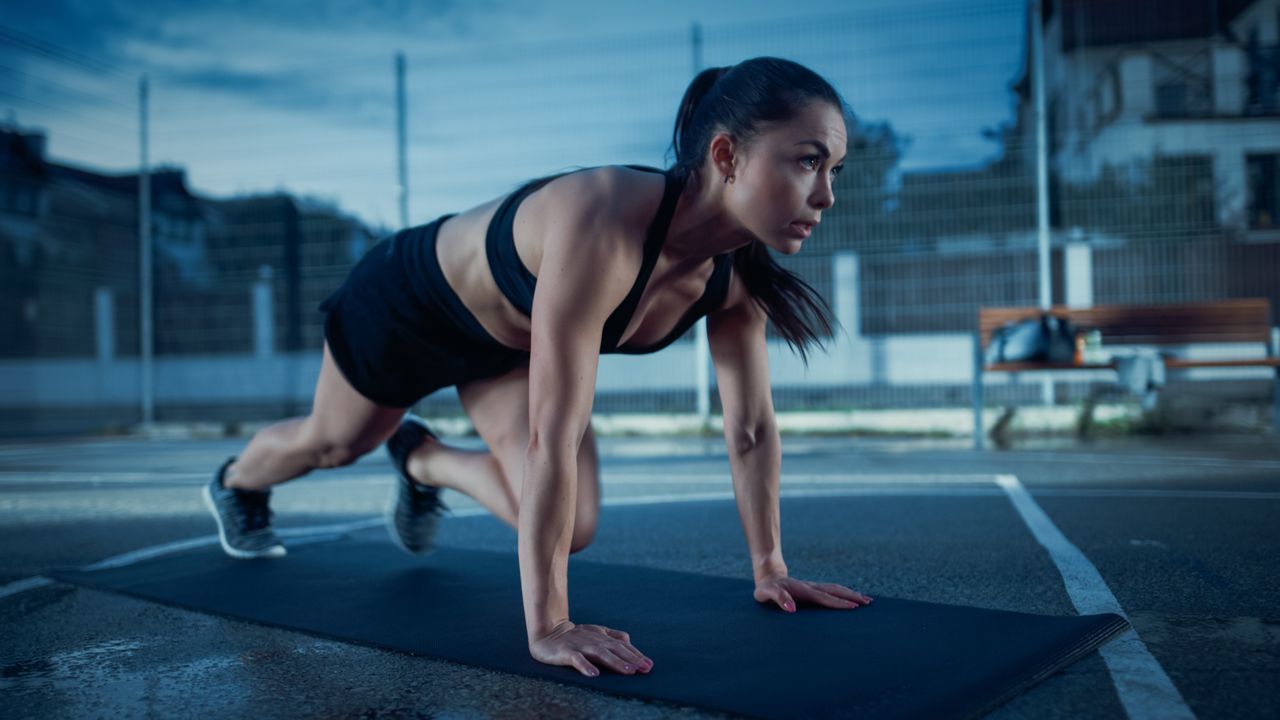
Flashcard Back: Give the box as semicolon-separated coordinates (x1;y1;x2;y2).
518;167;652;675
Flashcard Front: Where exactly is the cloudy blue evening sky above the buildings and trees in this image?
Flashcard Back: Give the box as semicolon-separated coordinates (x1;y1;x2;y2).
0;0;1025;228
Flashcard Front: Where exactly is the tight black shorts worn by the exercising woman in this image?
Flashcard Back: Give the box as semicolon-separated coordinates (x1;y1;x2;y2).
319;215;529;407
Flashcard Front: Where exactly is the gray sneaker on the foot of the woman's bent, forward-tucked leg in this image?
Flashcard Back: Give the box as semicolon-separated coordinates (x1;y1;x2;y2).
387;414;449;555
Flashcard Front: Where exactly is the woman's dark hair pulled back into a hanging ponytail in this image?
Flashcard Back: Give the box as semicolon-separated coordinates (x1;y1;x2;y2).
668;58;846;365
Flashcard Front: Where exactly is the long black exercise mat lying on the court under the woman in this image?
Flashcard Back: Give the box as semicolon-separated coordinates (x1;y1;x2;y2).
54;539;1128;719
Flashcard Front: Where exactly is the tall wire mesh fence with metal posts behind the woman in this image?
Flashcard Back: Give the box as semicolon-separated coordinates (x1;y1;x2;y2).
0;0;1280;428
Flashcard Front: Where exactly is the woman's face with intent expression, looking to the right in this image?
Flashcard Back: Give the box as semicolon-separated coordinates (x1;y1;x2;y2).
724;101;847;255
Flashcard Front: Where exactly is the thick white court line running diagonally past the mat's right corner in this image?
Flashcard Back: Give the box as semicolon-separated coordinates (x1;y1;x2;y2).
996;475;1196;720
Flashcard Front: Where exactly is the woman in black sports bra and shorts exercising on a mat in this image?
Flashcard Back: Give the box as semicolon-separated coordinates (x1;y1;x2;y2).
205;58;872;676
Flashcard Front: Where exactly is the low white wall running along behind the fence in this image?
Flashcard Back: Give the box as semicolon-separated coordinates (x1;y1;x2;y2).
0;333;1271;410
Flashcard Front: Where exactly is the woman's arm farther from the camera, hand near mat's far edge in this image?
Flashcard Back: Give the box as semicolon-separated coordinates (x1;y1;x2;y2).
707;300;872;612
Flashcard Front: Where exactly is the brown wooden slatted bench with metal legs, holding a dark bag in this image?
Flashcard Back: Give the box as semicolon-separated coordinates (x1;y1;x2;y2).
973;299;1280;450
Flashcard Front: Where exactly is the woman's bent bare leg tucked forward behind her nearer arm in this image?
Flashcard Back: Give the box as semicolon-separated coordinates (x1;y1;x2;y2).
408;366;600;552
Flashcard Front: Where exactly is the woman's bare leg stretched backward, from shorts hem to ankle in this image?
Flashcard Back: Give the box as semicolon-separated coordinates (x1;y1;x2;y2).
223;342;404;489
